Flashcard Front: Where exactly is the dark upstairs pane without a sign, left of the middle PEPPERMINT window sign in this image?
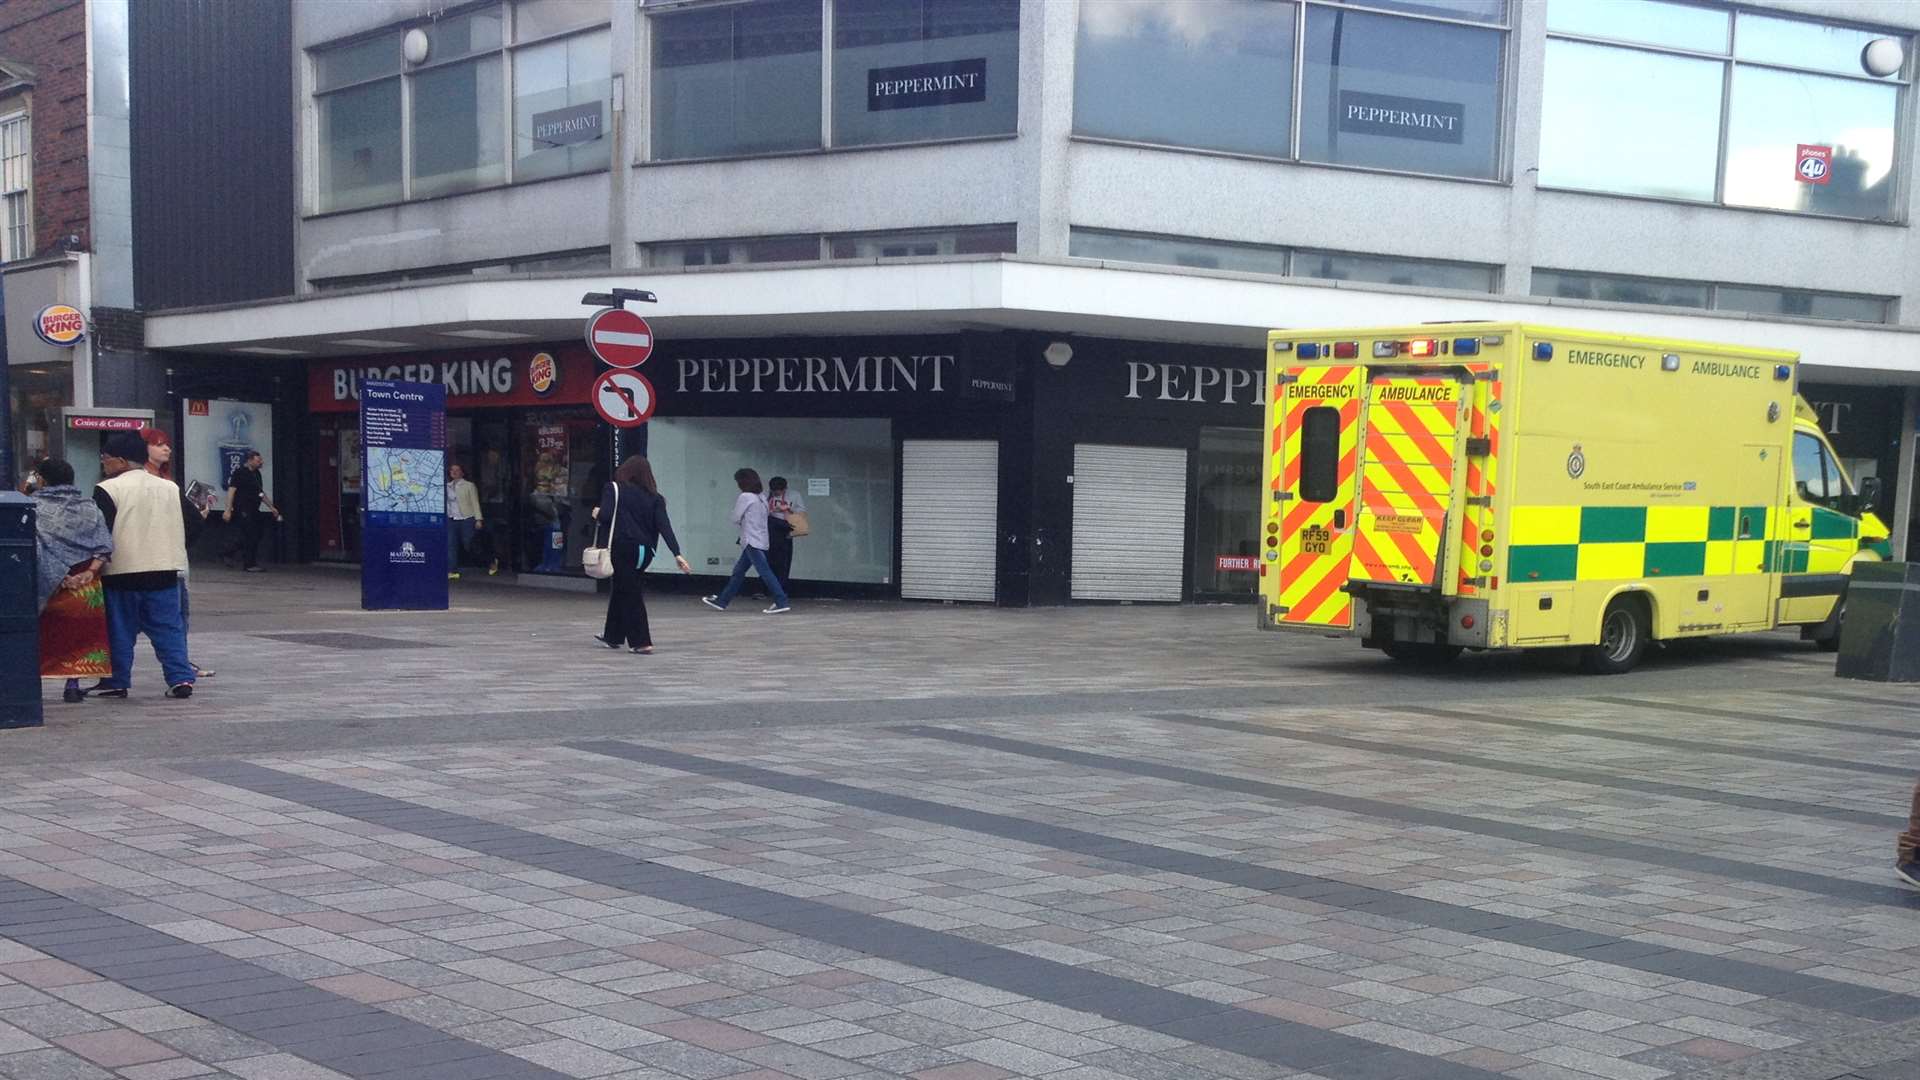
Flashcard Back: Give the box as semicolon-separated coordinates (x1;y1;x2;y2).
653;0;820;160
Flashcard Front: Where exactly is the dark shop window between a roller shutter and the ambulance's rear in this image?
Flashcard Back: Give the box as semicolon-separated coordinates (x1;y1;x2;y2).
1192;427;1260;596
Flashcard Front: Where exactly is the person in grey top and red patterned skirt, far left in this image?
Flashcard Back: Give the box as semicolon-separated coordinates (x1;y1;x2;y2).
27;457;113;701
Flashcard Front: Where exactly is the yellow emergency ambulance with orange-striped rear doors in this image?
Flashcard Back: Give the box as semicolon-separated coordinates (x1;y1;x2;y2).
1260;323;1891;675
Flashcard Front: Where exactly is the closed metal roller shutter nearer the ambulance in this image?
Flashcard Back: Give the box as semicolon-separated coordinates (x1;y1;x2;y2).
1073;444;1187;603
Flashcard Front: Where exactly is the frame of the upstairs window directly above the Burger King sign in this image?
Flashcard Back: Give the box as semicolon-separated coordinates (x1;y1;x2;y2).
303;0;624;217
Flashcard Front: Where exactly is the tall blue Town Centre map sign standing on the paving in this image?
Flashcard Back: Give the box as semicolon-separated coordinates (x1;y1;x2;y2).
359;379;447;611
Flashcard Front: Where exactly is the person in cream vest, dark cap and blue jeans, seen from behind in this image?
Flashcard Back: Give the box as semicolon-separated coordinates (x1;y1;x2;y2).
88;430;200;698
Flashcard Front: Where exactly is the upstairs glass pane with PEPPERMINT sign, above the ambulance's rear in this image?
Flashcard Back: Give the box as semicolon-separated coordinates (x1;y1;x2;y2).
1300;6;1505;179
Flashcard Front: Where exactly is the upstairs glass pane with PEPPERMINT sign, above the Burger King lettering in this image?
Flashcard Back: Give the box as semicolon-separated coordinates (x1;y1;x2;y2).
513;31;612;181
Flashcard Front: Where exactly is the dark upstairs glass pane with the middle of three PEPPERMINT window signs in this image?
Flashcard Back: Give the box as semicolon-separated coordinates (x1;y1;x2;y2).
833;0;1020;146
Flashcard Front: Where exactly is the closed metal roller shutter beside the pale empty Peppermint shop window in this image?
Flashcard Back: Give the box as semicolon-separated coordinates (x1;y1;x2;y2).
900;438;1000;603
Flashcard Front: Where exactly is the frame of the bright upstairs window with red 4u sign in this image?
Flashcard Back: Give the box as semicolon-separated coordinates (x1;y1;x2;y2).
1538;0;1920;225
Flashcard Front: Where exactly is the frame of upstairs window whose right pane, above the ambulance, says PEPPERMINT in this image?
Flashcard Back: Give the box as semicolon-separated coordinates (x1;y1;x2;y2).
1068;0;1523;186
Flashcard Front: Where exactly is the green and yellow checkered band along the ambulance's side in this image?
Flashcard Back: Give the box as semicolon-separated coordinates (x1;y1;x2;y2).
1507;505;1835;584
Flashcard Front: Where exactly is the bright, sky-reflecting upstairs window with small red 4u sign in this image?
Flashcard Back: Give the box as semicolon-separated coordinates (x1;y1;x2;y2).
1540;0;1910;221
